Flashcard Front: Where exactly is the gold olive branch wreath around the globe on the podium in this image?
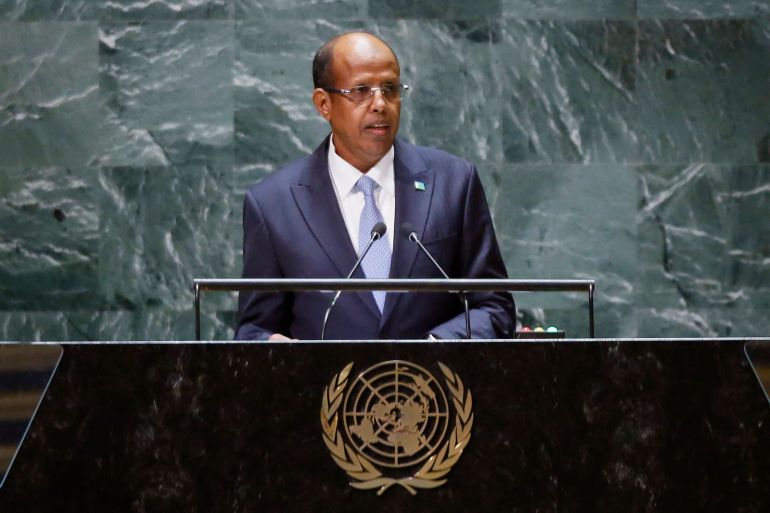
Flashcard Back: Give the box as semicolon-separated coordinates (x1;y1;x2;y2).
321;362;473;495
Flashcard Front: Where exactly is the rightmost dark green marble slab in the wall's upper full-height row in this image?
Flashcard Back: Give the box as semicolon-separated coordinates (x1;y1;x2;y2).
636;19;770;164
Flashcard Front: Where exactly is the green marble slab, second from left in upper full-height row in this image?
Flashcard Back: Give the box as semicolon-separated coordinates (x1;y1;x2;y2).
99;21;233;166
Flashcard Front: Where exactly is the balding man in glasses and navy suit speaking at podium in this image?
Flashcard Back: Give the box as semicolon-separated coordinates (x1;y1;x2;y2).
231;32;515;340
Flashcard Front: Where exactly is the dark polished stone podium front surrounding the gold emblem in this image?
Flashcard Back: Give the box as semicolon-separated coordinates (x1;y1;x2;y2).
0;339;770;513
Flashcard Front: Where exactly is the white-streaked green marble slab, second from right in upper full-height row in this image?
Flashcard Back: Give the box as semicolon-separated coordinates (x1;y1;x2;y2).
493;20;640;163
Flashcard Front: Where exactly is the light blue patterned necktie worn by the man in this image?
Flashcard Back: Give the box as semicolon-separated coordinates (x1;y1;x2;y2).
356;175;390;313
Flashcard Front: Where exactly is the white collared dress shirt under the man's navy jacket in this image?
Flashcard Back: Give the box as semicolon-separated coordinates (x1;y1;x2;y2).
329;137;396;250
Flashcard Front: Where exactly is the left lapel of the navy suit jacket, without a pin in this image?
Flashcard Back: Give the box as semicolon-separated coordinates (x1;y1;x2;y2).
291;137;380;316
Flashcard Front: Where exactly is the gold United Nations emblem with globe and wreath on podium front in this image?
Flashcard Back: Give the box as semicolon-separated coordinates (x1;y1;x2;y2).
321;360;473;495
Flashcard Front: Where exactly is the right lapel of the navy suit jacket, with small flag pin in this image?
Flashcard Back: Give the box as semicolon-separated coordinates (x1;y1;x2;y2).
381;139;435;326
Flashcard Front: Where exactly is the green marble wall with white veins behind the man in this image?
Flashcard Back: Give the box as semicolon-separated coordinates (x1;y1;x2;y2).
0;0;770;340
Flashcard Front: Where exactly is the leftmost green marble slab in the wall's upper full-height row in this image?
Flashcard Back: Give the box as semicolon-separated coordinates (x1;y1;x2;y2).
0;23;102;167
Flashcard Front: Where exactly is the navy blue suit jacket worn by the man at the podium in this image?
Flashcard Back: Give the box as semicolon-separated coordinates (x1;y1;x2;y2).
231;138;515;340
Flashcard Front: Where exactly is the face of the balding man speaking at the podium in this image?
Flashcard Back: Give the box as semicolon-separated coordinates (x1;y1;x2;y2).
314;34;401;172
